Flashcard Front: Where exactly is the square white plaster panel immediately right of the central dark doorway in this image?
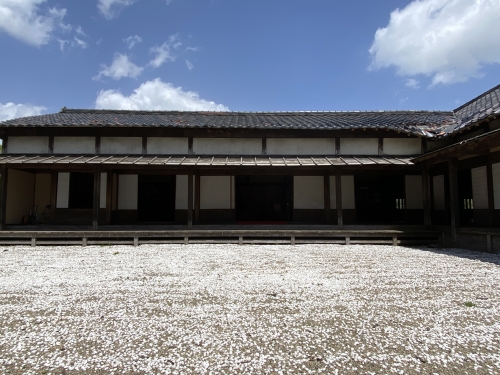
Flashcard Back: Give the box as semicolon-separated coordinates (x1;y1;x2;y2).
293;176;325;209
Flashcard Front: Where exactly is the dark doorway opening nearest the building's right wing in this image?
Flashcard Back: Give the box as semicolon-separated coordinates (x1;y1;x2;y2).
354;175;405;224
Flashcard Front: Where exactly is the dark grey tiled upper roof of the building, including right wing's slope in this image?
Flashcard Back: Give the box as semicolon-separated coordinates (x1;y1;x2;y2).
0;85;500;138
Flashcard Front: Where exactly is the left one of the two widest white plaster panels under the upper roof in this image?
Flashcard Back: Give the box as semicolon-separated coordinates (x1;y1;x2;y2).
193;138;262;155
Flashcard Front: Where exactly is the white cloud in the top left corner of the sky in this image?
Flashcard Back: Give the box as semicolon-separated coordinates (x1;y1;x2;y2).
0;0;71;46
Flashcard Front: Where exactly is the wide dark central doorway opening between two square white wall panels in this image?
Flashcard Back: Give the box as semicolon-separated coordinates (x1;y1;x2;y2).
235;176;293;224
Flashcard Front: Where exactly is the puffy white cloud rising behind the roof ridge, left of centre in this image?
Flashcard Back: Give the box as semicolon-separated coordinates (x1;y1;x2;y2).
95;78;228;111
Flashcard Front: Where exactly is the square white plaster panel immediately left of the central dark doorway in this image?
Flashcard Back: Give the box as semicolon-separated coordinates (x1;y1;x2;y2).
200;176;232;209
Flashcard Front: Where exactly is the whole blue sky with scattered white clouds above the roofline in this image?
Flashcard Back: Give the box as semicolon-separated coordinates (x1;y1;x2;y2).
0;0;500;120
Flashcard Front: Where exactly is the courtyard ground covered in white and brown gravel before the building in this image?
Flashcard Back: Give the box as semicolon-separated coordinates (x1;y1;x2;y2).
0;245;500;374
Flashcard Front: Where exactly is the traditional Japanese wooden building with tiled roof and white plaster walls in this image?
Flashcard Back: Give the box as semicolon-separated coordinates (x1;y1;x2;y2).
0;86;500;251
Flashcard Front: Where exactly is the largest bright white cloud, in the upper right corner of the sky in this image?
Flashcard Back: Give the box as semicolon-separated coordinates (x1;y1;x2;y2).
370;0;500;85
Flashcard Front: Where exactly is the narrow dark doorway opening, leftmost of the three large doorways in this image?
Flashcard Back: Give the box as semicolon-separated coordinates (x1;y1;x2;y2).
137;175;175;223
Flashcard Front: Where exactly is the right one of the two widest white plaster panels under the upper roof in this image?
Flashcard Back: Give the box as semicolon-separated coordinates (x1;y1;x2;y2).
266;138;335;155
